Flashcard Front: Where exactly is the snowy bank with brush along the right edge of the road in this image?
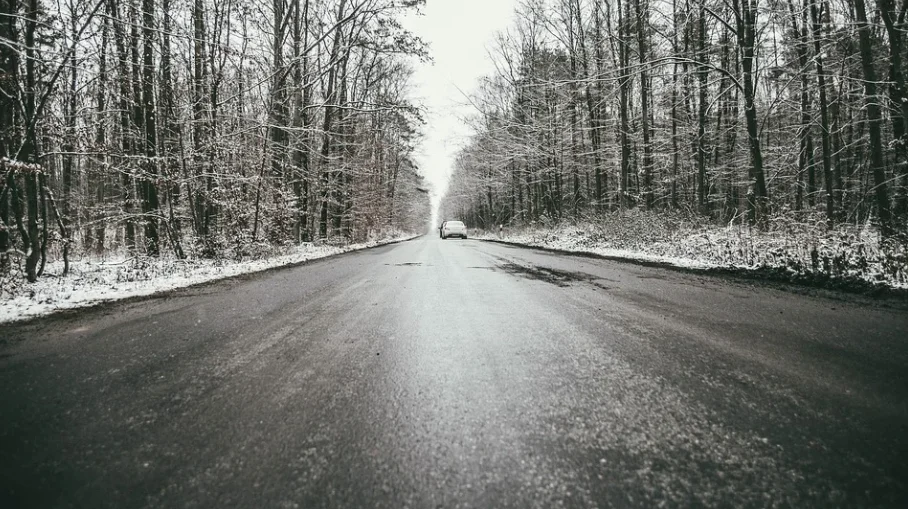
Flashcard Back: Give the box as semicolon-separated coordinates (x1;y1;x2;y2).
473;212;908;291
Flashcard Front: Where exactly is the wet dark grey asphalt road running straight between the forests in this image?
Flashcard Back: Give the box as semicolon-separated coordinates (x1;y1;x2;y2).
0;237;908;508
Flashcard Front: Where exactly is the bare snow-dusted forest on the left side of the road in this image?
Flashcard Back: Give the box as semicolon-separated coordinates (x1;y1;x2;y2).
0;0;430;281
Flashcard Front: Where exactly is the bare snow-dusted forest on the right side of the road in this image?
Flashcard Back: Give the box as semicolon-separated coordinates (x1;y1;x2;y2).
443;0;908;251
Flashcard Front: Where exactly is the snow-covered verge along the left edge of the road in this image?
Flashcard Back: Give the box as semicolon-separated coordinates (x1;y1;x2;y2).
0;235;416;323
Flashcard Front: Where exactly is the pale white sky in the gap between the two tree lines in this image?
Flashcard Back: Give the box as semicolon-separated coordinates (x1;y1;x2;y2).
403;0;518;223
